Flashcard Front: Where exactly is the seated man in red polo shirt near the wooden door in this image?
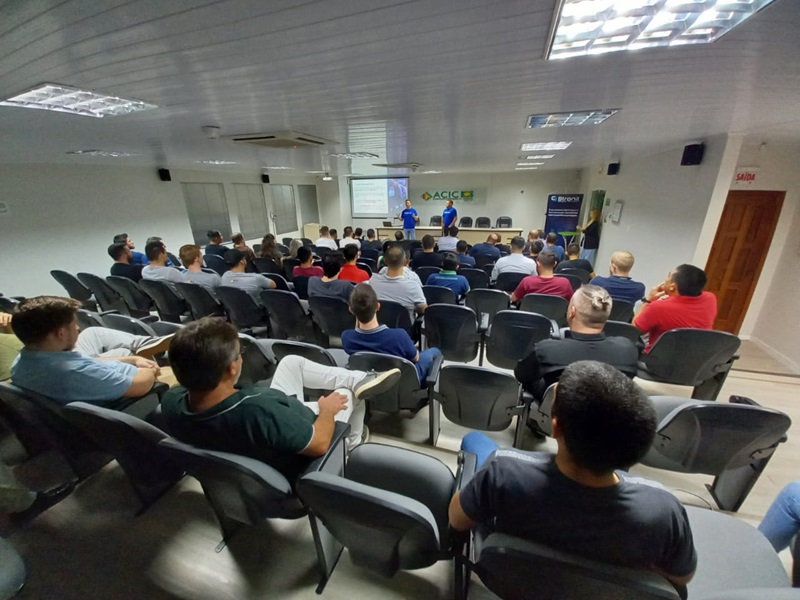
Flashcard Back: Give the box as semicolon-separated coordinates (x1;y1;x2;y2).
633;265;717;352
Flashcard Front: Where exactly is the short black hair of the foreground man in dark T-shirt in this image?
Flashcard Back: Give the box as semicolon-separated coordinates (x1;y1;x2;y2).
552;360;656;475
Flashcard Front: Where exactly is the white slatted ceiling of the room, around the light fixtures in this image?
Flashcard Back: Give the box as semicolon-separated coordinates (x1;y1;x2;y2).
0;0;800;175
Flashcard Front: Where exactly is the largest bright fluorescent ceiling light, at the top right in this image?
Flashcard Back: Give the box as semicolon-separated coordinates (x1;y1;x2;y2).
547;0;775;59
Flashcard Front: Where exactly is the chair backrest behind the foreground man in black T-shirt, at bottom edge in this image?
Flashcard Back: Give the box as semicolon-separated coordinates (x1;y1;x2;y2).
475;533;680;600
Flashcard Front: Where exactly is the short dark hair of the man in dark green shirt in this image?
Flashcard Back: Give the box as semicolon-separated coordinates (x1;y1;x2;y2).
169;317;239;392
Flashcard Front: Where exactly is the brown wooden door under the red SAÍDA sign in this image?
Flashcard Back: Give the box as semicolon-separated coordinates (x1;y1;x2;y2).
706;190;786;334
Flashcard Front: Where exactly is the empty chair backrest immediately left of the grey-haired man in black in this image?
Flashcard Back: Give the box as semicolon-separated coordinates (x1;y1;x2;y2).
438;365;519;431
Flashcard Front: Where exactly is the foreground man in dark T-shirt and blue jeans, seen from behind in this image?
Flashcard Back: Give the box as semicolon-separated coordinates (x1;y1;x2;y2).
450;361;697;591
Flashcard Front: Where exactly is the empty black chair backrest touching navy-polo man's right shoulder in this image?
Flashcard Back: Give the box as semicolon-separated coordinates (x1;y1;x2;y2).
423;304;480;362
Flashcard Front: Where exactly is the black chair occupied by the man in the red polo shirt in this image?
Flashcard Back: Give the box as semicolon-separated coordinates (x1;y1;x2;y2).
638;329;741;400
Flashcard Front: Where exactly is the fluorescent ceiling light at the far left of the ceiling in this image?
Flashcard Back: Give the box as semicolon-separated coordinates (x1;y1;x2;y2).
0;83;158;118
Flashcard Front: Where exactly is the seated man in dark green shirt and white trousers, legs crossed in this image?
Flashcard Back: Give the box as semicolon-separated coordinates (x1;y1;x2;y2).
161;317;400;472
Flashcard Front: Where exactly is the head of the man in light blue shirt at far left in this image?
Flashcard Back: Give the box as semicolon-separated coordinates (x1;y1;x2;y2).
11;296;81;350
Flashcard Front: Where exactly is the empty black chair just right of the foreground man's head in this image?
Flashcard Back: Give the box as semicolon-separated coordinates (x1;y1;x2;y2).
642;396;792;512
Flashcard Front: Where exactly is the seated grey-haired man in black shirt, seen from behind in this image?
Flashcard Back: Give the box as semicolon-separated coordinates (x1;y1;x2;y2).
514;285;639;399
